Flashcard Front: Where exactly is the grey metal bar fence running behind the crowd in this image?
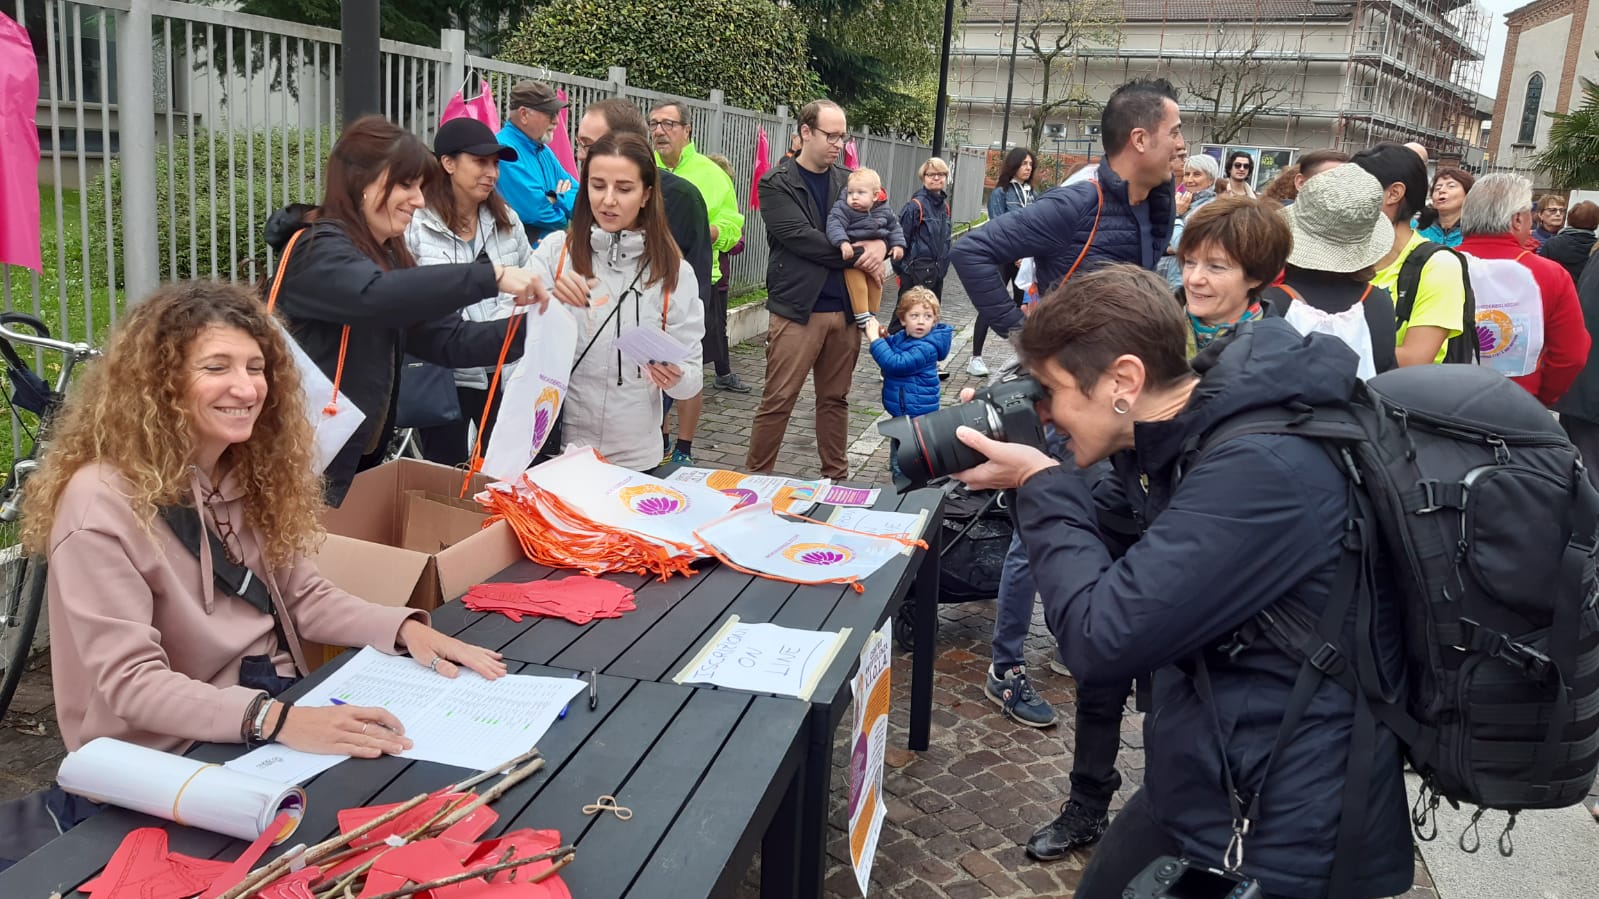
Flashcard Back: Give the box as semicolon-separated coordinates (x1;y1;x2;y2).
0;0;940;383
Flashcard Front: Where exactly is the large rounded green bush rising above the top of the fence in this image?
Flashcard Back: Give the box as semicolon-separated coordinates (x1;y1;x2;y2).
499;0;822;112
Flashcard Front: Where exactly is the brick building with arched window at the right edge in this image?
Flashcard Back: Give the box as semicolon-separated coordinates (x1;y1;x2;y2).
1489;0;1599;187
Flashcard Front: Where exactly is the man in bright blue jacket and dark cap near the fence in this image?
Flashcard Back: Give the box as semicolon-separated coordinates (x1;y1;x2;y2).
497;82;577;246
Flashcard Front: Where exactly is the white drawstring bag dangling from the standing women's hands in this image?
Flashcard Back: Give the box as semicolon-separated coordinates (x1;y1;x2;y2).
482;302;577;481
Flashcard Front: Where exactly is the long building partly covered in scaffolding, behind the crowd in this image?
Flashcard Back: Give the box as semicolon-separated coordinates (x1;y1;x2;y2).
950;0;1483;163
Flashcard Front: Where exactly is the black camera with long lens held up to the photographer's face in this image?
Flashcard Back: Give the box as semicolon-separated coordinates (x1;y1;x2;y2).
878;373;1046;493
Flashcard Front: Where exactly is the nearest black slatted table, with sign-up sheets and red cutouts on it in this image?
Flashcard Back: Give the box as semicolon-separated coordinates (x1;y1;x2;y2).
0;657;809;899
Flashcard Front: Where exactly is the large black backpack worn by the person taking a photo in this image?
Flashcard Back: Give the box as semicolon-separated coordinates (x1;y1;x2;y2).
1186;365;1599;897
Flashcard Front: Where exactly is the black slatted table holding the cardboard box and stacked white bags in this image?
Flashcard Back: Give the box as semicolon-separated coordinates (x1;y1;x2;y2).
433;489;943;896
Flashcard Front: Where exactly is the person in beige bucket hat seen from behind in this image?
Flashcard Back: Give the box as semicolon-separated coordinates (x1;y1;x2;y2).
1266;165;1399;378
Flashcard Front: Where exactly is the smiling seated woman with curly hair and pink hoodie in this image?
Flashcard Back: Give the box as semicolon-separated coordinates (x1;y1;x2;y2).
4;283;505;851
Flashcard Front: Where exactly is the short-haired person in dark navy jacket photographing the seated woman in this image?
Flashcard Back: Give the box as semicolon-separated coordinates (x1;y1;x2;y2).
956;266;1414;899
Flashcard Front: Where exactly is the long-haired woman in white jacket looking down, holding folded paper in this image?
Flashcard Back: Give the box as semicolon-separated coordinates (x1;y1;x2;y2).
531;134;705;472
